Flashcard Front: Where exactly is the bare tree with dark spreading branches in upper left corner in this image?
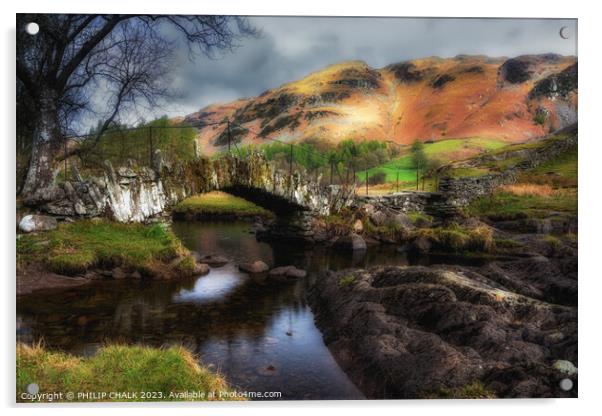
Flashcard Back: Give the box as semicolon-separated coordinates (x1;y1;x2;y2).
17;14;257;204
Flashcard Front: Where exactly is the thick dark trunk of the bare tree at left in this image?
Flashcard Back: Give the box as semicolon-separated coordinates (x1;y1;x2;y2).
21;91;63;205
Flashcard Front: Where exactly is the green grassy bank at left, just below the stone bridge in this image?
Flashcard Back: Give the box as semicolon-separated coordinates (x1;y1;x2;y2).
17;220;187;275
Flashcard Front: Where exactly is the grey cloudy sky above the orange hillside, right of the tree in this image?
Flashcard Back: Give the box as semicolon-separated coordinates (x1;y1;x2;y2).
158;17;577;116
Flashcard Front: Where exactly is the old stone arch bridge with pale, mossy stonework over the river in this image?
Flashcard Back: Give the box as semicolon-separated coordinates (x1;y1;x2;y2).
41;152;355;222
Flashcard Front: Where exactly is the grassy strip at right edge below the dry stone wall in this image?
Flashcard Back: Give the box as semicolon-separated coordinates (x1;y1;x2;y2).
467;190;577;220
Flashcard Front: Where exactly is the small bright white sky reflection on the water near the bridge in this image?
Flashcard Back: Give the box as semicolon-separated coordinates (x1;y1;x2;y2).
173;264;246;305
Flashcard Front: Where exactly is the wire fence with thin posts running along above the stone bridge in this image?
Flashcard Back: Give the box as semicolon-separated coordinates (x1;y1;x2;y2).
59;120;432;194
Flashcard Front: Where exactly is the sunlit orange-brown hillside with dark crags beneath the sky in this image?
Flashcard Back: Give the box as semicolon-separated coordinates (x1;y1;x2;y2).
184;54;577;154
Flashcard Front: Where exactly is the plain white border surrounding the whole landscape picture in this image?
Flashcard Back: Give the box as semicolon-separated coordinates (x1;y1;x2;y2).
0;0;602;416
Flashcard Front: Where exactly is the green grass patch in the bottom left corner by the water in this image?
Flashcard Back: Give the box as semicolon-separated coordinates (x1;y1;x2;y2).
17;344;237;402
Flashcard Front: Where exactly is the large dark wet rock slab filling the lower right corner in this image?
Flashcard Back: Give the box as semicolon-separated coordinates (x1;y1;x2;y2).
309;266;577;398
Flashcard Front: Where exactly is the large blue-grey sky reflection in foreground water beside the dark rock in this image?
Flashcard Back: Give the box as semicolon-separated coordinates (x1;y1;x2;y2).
199;300;362;399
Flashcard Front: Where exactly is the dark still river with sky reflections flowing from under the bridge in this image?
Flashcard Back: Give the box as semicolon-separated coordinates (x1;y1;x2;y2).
17;222;482;400
